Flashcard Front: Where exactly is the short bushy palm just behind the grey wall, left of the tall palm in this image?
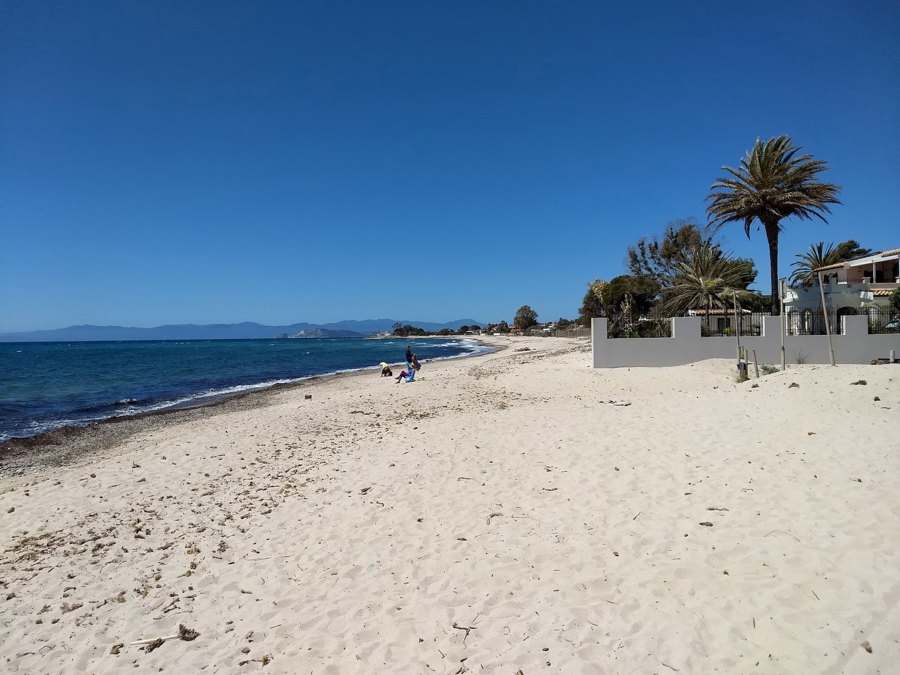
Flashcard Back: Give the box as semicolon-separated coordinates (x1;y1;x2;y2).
663;244;749;336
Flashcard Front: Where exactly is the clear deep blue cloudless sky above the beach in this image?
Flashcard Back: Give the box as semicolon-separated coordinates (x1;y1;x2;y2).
0;0;900;332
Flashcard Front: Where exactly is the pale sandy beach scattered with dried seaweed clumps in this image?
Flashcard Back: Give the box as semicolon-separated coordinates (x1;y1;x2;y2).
0;338;900;675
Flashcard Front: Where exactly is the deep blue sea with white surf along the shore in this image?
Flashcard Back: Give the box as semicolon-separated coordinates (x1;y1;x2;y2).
0;338;491;442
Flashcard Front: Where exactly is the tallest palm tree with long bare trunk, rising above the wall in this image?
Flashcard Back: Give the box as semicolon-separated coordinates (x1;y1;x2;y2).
706;136;840;314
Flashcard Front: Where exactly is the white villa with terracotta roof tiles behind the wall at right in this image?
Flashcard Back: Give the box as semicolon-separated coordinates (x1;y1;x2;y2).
784;248;900;335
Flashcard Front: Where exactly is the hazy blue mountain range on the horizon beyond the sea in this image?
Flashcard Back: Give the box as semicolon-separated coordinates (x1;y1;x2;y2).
0;319;485;342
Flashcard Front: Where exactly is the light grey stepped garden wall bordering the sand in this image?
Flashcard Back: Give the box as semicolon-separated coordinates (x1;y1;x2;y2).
591;316;900;368
